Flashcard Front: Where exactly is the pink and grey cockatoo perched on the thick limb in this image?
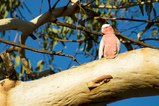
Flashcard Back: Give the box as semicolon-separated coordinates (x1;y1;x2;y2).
98;24;120;59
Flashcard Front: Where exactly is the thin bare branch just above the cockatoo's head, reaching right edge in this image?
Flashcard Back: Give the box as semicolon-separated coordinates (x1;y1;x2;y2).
94;17;159;23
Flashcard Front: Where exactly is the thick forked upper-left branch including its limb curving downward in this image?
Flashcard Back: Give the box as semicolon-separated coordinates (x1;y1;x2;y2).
0;0;78;77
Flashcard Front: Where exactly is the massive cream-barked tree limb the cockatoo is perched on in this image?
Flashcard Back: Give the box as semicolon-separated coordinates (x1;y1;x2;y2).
0;48;159;106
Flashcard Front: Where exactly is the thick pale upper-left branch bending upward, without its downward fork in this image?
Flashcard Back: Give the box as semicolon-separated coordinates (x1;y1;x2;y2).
0;0;79;35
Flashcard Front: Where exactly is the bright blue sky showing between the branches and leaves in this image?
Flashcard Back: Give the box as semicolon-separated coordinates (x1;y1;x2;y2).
0;0;159;106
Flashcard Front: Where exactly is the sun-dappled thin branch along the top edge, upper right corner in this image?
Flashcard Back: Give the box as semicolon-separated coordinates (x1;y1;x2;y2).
81;0;159;9
